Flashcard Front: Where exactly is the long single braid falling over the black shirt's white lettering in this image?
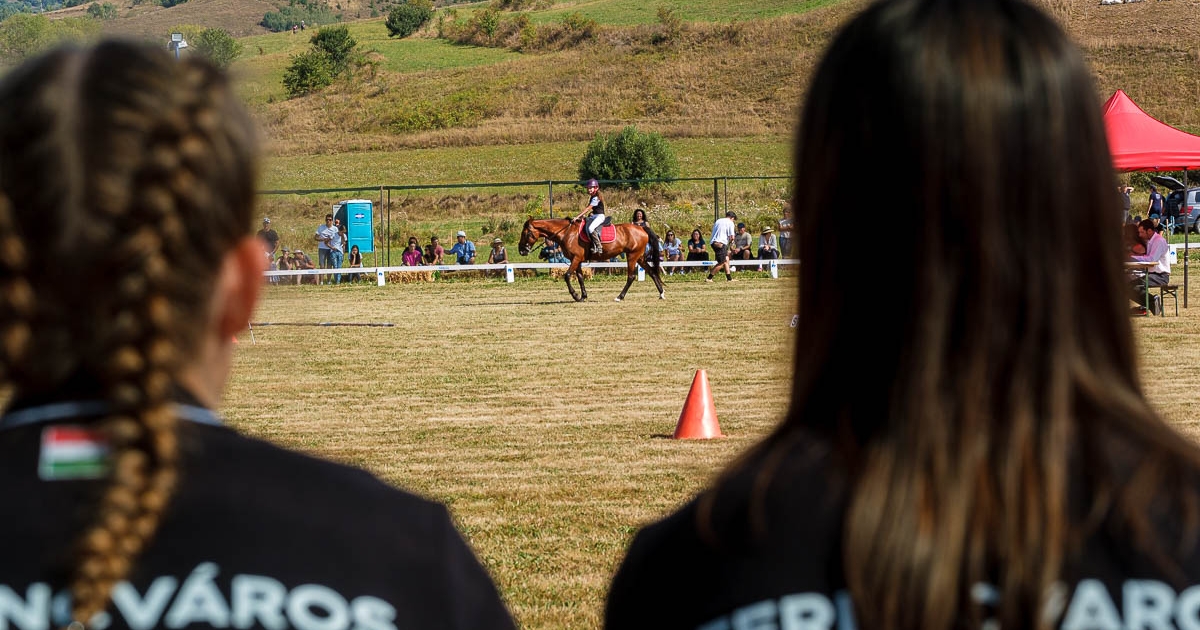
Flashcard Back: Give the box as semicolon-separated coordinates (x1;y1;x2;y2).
71;54;244;625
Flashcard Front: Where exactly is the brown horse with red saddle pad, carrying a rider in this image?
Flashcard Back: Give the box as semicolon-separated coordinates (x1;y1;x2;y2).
517;218;666;302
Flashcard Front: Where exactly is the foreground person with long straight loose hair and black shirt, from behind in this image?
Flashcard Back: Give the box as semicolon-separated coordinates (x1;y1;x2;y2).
605;0;1200;630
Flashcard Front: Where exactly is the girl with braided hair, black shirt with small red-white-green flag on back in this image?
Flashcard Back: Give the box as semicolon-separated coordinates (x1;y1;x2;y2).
0;42;512;630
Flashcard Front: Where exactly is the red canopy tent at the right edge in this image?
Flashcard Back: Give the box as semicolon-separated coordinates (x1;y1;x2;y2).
1104;90;1200;307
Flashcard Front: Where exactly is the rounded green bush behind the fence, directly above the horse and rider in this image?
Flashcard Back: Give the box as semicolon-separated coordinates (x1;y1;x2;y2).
580;125;679;188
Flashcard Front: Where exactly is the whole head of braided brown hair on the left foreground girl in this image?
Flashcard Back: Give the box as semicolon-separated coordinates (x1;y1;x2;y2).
0;41;256;628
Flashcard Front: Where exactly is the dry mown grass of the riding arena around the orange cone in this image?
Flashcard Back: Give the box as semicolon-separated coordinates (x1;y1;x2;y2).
224;268;1200;629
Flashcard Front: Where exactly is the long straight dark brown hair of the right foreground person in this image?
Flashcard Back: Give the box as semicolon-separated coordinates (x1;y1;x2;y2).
702;0;1200;630
